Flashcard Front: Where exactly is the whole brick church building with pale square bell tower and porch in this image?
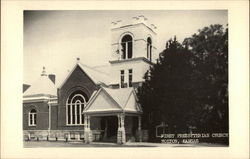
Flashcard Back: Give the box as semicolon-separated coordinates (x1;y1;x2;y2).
23;15;157;144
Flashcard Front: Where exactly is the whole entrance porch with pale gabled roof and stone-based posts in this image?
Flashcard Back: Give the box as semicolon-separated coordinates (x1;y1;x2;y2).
83;87;142;144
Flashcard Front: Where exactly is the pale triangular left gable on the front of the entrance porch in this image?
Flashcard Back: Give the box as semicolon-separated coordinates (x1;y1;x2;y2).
85;90;122;112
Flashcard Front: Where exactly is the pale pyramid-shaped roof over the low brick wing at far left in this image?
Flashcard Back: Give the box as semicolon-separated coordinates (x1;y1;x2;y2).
24;75;57;96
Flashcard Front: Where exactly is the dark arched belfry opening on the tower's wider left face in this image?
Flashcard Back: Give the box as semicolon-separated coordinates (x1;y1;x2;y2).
121;35;133;59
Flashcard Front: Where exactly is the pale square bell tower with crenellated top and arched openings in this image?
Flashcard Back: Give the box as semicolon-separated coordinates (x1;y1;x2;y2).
109;15;157;88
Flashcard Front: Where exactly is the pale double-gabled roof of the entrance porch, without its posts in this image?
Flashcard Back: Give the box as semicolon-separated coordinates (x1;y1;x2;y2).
83;87;142;115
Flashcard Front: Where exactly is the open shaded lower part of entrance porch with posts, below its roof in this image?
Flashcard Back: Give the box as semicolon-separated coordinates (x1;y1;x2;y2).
84;113;142;144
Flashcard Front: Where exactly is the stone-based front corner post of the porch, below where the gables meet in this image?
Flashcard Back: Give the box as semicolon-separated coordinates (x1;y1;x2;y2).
117;114;126;144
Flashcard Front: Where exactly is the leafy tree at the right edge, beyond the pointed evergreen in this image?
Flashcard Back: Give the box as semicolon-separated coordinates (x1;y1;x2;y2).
183;25;228;132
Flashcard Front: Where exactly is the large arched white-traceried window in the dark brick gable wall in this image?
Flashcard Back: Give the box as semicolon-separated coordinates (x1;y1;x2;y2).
66;90;87;125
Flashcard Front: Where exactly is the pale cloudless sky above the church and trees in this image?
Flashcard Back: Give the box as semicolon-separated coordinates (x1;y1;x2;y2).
23;10;228;86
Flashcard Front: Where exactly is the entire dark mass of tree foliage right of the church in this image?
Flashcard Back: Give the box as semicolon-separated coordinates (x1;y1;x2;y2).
138;25;228;138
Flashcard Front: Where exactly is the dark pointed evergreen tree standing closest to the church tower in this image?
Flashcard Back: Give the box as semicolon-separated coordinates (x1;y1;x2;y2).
138;38;192;139
